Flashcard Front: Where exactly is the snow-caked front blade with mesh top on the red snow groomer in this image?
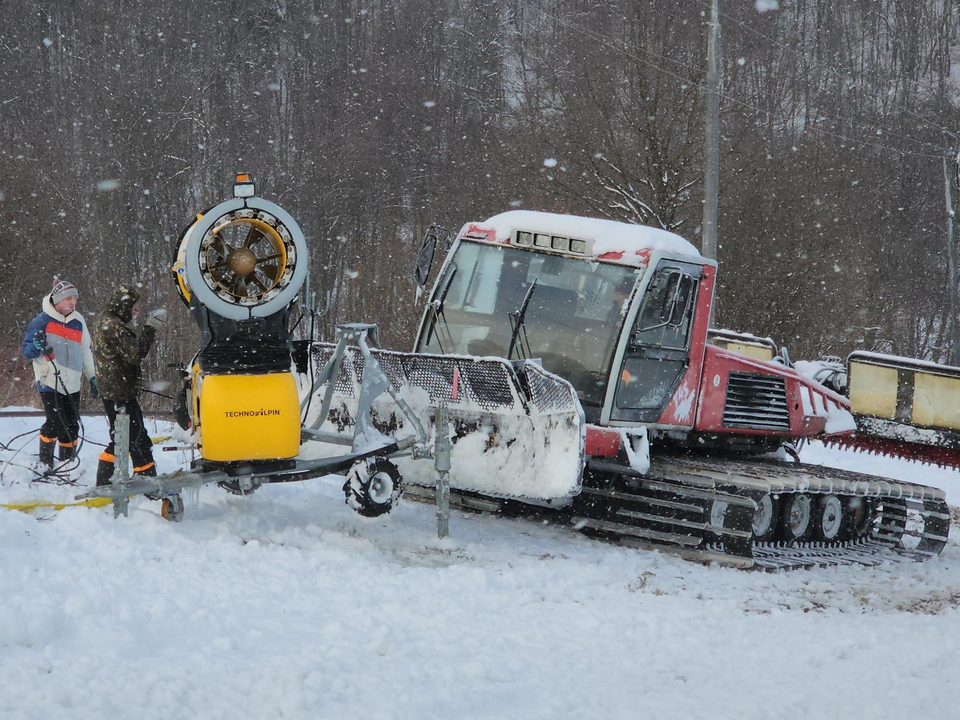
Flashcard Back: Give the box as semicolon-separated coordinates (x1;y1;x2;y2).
306;343;586;500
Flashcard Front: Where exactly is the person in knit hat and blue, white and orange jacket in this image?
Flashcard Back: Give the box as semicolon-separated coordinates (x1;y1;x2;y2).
22;280;99;468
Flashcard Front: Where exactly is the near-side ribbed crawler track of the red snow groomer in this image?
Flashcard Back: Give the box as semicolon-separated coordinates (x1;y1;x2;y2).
573;456;950;571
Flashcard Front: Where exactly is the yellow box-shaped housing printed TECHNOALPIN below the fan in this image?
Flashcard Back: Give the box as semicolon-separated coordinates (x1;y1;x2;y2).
194;372;300;462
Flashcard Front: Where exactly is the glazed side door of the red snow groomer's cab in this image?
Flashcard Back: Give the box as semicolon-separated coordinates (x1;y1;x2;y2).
610;260;703;423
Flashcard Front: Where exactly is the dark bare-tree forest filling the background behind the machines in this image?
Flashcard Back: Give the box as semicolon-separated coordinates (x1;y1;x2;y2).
0;0;960;407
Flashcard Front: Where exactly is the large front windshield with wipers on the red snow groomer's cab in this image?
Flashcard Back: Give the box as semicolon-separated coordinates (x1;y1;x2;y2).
417;241;639;414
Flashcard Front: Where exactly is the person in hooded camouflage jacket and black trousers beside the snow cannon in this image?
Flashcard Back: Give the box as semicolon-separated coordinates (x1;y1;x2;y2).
93;285;166;485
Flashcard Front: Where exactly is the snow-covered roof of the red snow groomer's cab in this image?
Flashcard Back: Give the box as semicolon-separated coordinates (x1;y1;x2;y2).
458;210;703;265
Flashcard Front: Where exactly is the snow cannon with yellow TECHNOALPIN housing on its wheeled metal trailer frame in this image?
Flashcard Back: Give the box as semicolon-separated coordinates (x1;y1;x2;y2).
78;175;484;520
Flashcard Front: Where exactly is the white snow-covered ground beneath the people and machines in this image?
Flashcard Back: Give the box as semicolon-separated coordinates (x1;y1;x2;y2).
0;417;960;720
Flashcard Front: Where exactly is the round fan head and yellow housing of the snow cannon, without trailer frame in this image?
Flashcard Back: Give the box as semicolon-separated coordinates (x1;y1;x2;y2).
173;174;307;467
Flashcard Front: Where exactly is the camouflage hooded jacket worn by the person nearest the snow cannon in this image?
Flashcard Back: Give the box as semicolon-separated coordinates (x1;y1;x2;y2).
93;285;156;401
